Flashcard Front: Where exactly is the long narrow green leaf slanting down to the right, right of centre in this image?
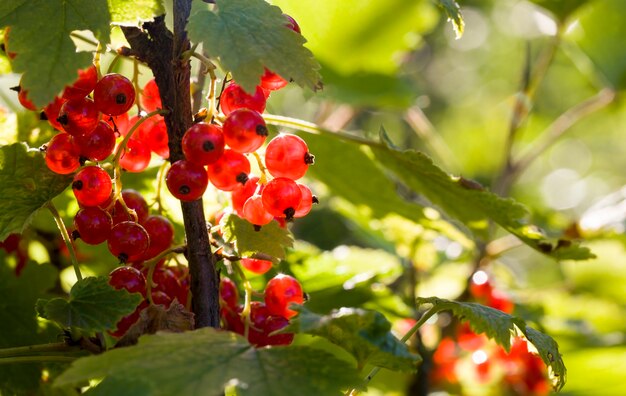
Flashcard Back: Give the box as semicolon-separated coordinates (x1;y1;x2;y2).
370;129;595;260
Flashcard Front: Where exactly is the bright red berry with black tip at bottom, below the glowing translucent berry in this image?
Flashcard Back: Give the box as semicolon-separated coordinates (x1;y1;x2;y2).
262;177;302;220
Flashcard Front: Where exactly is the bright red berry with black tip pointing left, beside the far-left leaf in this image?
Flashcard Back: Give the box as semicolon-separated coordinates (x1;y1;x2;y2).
72;166;112;206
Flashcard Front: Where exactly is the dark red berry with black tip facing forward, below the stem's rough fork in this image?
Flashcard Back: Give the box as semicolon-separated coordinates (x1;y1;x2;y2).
93;73;135;116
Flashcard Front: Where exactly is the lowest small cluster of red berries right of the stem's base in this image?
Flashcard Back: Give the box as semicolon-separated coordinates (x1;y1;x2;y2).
220;274;304;347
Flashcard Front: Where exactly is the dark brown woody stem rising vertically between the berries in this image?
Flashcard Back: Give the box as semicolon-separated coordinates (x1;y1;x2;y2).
122;0;219;327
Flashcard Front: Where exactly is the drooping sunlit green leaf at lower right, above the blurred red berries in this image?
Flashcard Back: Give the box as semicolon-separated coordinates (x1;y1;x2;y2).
416;297;567;391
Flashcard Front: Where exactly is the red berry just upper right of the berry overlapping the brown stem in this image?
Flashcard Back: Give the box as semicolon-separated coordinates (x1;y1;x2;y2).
207;149;250;191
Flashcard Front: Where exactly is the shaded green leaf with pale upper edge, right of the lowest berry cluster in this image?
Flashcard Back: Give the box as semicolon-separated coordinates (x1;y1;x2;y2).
285;306;421;371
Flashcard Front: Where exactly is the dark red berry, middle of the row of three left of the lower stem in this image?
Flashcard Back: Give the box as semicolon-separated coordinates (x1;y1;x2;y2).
107;221;150;262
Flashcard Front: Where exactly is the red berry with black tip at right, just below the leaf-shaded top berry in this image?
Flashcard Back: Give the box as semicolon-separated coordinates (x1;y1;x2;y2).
222;109;268;153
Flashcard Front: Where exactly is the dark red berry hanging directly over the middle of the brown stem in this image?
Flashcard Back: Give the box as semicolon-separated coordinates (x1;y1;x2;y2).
165;160;209;202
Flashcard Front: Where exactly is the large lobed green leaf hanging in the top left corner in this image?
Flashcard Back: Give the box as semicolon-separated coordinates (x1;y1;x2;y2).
0;0;111;107
